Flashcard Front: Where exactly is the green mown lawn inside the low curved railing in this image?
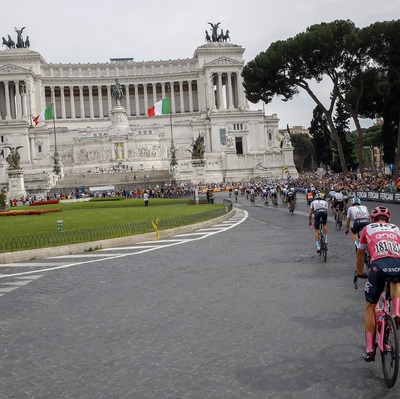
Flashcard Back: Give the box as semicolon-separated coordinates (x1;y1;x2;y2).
0;198;225;237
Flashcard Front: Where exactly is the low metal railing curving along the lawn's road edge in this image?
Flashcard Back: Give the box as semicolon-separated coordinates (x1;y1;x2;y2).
0;201;232;252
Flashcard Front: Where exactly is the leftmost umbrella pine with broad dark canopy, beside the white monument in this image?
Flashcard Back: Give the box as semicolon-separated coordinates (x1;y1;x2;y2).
242;20;368;173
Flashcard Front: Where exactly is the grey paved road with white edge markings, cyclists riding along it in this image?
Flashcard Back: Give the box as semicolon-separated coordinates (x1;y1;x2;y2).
0;193;400;399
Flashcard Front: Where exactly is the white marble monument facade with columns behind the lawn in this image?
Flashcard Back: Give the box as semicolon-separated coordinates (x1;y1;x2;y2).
0;38;297;191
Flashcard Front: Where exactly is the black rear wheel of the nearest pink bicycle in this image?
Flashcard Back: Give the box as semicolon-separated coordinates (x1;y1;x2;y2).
382;315;399;388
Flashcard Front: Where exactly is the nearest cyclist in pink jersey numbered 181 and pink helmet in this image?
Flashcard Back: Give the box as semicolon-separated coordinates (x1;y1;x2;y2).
356;206;400;362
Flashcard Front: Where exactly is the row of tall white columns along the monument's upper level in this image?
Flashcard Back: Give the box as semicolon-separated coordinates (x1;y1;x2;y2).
0;71;244;120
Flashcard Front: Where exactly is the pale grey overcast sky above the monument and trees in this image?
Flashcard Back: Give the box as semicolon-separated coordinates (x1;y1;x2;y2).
4;0;400;128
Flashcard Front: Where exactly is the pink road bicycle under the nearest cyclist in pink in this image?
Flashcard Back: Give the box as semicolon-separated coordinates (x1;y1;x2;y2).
374;278;400;388
